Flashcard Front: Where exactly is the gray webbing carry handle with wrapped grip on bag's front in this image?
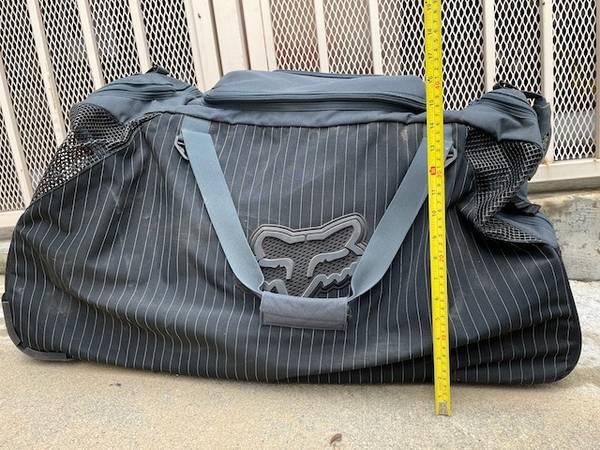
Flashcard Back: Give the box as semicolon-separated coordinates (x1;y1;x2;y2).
182;117;452;330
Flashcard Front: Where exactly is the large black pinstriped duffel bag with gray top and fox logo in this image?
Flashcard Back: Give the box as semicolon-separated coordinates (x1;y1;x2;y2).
3;71;581;383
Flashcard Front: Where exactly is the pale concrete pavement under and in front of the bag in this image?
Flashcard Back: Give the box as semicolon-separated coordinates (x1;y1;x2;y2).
0;282;600;449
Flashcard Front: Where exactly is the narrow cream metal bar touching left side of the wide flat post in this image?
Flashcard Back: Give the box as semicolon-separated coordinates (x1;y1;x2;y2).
193;0;223;87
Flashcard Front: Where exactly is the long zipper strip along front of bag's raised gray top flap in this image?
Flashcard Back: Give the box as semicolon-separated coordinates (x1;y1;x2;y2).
204;92;425;112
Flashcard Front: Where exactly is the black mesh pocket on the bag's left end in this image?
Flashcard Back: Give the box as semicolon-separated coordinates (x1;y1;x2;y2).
33;103;152;201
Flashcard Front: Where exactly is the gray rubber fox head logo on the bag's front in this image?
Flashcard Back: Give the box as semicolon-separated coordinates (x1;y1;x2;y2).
250;214;367;297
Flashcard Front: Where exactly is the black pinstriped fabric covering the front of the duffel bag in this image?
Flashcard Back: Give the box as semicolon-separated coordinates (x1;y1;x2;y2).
5;114;580;383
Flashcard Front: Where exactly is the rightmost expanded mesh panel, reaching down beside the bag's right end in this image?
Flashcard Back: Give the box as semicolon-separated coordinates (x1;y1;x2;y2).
553;0;597;159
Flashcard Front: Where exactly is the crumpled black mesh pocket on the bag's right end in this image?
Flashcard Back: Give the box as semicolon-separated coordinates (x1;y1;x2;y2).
460;128;544;242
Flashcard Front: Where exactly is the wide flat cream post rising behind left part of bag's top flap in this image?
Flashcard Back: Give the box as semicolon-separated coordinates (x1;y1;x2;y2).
212;0;248;73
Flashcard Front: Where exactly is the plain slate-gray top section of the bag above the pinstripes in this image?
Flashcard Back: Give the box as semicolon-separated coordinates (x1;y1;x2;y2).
77;71;541;145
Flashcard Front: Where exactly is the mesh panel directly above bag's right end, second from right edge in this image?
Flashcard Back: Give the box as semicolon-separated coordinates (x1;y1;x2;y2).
494;0;542;92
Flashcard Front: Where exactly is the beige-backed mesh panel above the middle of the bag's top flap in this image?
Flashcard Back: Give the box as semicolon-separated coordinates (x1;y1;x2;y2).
271;0;319;71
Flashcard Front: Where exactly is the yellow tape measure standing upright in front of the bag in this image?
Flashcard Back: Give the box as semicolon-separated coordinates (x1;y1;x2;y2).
424;0;450;416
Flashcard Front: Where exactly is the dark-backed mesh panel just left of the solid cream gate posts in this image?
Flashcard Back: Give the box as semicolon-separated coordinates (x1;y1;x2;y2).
140;0;196;84
